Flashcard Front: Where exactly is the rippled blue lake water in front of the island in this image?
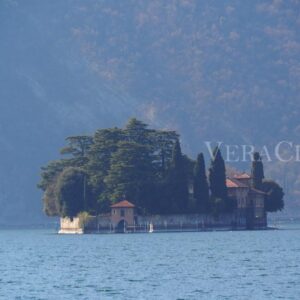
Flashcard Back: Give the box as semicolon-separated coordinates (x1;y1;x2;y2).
0;225;300;300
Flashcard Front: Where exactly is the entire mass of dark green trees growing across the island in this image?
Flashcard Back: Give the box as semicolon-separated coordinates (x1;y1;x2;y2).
38;118;284;218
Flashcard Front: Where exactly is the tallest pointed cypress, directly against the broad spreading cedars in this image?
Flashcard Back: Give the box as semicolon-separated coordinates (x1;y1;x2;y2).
168;140;189;213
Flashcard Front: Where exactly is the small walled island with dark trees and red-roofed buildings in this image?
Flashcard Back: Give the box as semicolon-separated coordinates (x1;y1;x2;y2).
38;118;284;234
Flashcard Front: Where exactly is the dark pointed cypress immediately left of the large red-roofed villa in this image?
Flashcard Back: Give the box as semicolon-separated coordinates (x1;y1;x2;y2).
209;147;227;202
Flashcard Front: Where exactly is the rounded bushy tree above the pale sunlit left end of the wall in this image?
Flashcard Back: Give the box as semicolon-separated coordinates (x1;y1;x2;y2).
55;167;85;218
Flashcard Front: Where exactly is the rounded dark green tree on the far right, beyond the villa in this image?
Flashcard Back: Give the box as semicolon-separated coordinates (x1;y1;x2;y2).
261;180;284;212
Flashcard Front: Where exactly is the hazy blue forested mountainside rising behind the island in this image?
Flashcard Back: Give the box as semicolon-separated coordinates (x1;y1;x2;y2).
0;0;300;223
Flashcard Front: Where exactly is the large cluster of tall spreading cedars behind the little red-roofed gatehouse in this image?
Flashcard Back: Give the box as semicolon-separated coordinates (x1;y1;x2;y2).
38;118;179;215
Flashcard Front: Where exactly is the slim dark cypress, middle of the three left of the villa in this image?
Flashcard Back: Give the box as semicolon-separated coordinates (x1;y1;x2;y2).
193;153;209;213
